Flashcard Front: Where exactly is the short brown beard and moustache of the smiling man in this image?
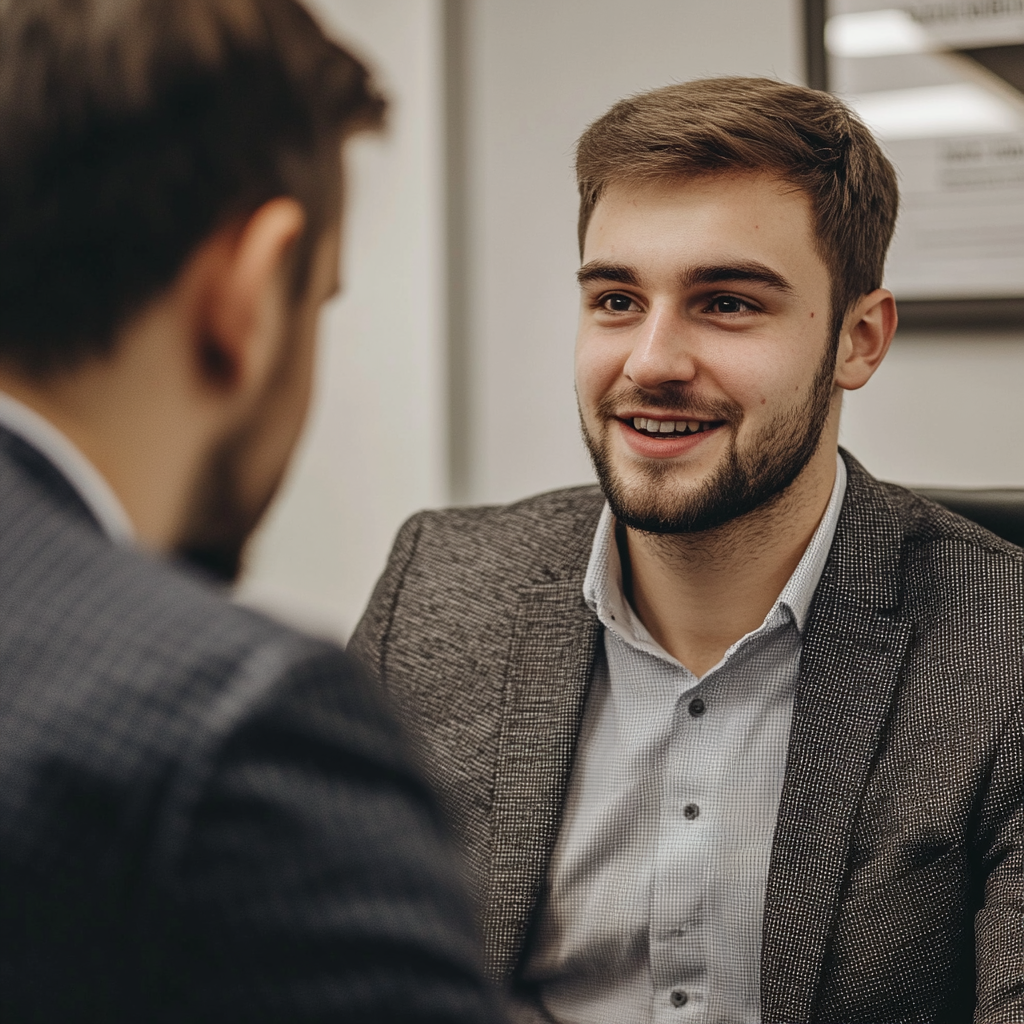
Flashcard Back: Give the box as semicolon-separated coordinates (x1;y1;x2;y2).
581;332;839;535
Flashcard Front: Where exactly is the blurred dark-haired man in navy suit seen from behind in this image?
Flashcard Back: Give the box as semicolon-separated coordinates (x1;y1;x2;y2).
0;0;492;1024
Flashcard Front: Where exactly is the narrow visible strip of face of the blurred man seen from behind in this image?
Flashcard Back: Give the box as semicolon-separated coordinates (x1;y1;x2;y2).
180;224;341;581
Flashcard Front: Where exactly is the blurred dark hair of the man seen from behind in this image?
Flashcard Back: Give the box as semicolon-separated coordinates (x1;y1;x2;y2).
0;0;384;375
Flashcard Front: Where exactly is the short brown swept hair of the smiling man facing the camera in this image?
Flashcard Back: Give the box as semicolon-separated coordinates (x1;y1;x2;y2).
577;78;899;335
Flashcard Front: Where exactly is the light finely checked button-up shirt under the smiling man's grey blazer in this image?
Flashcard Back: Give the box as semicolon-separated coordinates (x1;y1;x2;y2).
523;457;846;1024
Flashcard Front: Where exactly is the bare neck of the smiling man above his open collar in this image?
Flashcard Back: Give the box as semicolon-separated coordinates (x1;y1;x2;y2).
624;437;836;678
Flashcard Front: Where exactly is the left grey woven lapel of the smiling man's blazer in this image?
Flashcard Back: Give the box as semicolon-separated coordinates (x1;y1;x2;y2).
483;574;600;978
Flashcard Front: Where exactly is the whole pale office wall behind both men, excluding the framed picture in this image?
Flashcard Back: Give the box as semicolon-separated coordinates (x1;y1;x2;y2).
240;0;1024;639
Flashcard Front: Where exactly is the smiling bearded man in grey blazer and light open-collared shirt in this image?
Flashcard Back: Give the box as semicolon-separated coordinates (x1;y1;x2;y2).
353;79;1024;1024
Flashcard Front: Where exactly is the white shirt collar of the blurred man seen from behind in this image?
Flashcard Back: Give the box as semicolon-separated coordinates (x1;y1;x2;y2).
0;391;135;545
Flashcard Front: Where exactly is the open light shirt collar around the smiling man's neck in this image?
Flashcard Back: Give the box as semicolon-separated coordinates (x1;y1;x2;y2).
583;453;847;656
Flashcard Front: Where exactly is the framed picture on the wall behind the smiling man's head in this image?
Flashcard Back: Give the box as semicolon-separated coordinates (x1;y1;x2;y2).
806;0;1024;329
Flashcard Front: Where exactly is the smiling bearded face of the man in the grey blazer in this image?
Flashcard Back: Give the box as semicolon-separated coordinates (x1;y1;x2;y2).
575;174;838;534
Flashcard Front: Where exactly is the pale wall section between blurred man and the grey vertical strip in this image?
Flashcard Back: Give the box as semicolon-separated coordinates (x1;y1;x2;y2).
241;0;447;637
